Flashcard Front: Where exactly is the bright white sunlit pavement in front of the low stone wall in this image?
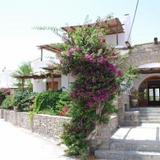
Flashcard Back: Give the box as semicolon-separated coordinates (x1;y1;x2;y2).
0;119;73;160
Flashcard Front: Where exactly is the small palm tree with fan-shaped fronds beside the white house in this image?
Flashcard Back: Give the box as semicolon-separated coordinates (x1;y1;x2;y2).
13;62;33;90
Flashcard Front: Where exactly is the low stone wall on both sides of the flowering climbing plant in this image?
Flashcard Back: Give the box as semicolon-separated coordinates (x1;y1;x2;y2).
0;109;119;150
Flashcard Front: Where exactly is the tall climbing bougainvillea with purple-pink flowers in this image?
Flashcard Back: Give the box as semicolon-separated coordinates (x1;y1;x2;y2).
42;17;138;159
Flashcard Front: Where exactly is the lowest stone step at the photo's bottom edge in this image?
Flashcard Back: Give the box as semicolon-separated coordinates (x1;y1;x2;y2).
95;150;160;160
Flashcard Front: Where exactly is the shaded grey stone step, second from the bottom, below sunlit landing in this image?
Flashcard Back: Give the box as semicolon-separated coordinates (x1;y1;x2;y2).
108;139;160;153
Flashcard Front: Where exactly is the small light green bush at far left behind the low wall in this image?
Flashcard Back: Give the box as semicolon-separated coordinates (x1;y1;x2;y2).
2;95;14;109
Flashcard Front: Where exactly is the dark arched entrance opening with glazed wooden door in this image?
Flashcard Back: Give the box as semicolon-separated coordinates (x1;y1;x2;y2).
138;76;160;107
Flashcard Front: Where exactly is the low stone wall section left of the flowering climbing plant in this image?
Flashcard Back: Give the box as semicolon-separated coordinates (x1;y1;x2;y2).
0;109;70;138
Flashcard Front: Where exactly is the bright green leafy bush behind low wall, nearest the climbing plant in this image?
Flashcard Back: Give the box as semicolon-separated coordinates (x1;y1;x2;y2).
33;91;61;114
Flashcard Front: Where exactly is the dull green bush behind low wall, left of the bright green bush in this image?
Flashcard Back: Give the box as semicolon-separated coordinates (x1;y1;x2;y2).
14;90;36;111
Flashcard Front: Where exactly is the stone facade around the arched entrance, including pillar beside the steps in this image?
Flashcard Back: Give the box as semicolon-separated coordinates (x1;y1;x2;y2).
118;43;160;126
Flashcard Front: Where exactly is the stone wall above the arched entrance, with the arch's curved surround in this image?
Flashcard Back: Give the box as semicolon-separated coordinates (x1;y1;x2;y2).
126;43;160;90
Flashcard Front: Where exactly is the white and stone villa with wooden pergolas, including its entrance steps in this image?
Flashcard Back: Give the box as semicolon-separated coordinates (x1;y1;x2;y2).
0;15;160;160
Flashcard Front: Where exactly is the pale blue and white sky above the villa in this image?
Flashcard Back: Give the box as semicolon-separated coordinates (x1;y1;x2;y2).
0;0;160;71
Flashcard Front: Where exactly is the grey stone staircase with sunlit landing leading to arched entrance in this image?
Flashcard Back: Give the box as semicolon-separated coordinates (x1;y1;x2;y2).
95;108;160;160
